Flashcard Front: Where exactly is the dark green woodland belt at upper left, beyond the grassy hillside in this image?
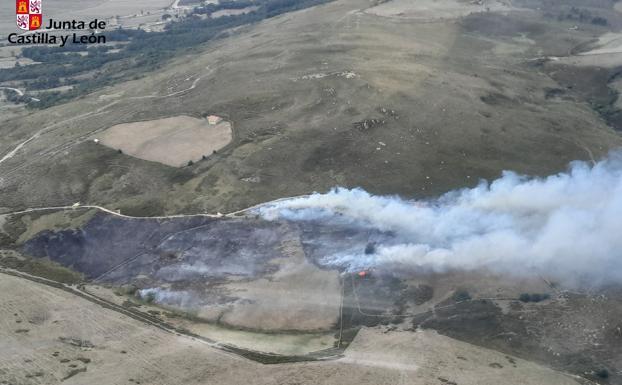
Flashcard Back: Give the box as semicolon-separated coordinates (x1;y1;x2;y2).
0;0;329;108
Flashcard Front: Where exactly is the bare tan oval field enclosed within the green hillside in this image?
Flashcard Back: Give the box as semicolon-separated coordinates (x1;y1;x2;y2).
98;116;231;167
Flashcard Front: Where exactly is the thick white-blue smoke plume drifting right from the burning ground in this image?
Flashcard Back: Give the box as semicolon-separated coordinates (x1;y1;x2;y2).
259;153;622;284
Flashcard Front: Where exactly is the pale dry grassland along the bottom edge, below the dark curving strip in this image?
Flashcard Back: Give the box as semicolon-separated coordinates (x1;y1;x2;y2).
0;274;576;385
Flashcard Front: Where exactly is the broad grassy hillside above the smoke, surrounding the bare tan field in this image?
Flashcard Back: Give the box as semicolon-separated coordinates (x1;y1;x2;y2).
0;0;622;214
